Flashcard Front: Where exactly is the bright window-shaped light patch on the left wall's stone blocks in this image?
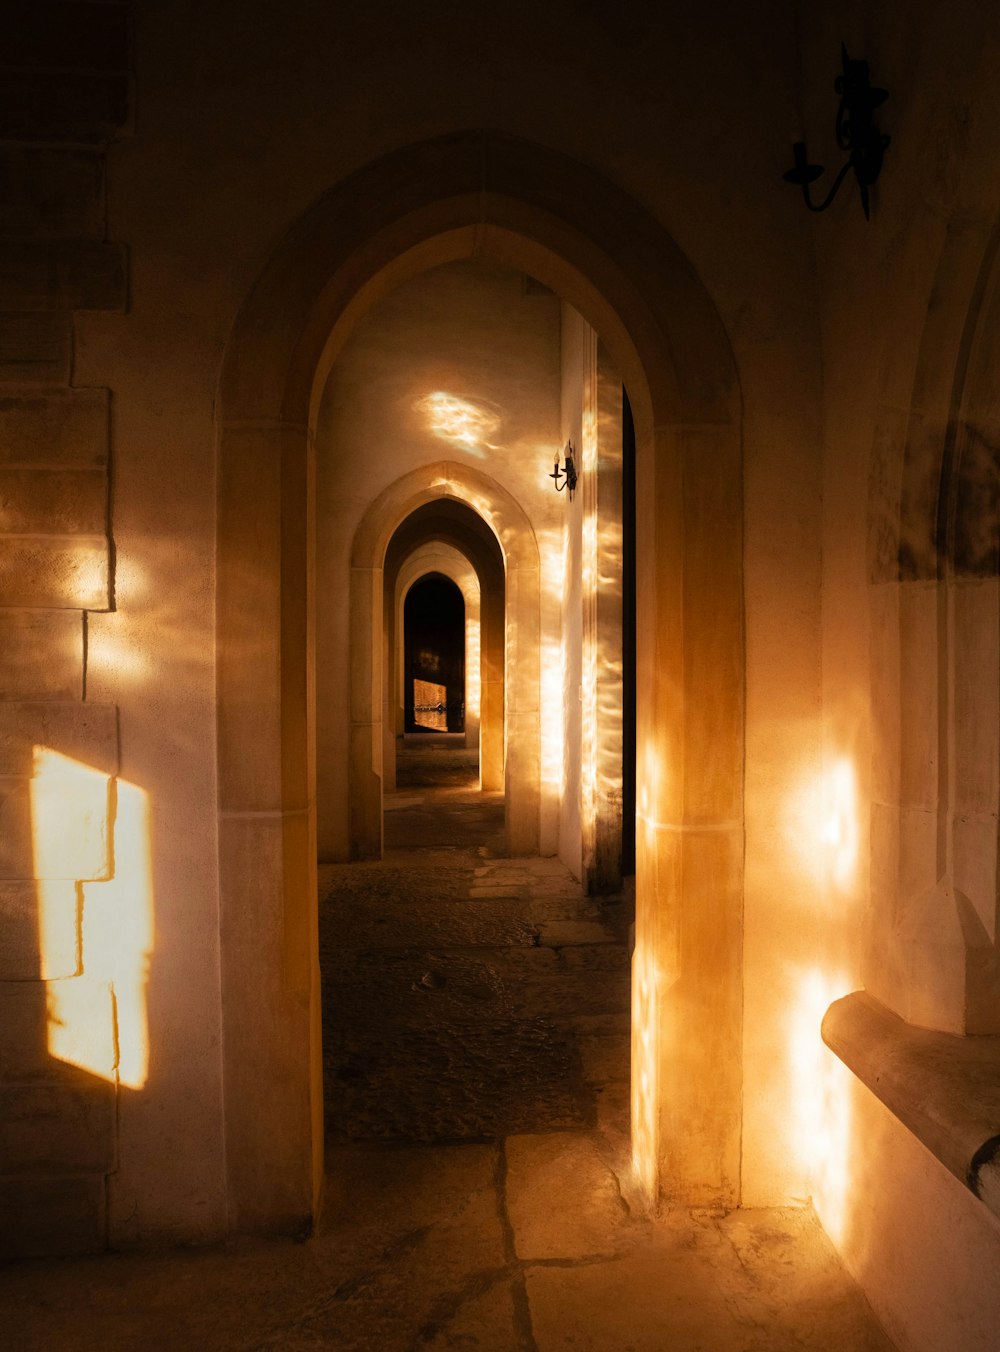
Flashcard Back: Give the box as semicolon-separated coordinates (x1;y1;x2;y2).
31;746;153;1088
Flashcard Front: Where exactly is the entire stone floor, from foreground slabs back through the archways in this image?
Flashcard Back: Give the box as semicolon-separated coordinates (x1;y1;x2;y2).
0;750;892;1352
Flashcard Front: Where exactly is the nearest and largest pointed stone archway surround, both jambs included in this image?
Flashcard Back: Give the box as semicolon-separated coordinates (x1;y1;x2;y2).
218;131;743;1232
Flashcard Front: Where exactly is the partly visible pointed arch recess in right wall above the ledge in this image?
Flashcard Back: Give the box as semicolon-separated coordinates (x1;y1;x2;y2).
865;215;1000;1034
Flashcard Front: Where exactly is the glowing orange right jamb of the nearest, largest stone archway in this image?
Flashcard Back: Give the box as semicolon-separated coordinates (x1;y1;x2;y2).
634;427;743;1206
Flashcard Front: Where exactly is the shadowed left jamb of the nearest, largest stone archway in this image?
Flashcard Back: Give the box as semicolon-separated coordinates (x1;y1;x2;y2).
218;422;323;1233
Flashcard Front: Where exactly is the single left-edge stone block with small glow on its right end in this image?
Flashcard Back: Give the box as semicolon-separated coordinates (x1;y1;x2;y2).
0;535;111;610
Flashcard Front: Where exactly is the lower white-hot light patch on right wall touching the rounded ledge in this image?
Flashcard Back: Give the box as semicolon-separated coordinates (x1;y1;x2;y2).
788;968;851;1242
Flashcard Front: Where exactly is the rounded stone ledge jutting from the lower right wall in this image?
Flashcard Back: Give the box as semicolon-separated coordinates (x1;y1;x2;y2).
822;991;1000;1217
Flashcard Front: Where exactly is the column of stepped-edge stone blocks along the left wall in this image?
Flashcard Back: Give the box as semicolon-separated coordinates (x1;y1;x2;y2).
0;0;131;1256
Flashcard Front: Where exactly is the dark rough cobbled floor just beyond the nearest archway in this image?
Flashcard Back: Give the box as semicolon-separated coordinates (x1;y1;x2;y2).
320;779;630;1140
